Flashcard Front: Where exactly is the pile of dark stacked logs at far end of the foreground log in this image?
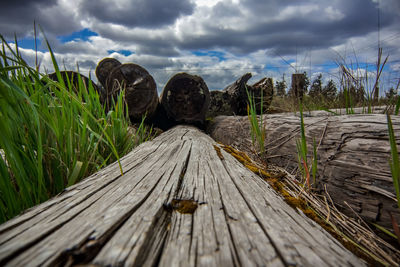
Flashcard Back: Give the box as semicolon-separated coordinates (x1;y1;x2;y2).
96;58;273;130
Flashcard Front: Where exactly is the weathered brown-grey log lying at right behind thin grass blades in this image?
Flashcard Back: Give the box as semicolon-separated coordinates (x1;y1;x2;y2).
209;112;400;229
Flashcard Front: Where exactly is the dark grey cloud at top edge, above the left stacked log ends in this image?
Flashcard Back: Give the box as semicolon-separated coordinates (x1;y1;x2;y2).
81;0;195;28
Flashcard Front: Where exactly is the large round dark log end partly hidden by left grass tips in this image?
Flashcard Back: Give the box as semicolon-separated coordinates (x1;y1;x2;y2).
105;63;158;121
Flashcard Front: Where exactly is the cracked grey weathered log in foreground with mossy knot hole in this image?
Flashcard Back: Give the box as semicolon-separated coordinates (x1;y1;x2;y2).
0;126;364;267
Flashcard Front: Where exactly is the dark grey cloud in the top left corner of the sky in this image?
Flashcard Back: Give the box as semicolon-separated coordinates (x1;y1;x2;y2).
0;0;80;38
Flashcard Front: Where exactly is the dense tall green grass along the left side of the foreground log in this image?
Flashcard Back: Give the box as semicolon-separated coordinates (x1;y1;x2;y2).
0;36;151;222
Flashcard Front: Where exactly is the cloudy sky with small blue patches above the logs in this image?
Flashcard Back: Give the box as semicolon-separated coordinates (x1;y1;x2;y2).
0;0;400;91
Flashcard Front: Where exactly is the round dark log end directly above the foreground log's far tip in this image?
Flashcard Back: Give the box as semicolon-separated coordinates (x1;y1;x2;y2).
161;73;210;123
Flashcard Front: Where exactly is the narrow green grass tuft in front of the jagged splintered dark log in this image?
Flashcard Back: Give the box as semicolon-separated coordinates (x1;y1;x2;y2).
246;88;265;155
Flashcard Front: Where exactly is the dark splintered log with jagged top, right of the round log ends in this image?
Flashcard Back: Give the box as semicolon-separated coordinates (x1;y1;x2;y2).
207;73;274;117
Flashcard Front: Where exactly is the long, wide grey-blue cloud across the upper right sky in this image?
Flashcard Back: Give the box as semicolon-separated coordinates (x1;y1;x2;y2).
174;0;399;55
